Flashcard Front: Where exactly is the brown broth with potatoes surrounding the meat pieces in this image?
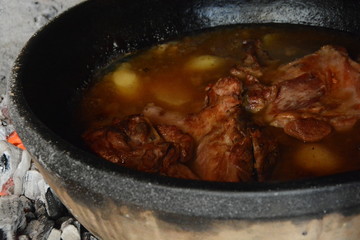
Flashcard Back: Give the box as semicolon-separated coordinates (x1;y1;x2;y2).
76;26;360;181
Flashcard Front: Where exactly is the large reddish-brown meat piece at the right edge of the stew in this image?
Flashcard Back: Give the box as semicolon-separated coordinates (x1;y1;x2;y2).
236;46;360;142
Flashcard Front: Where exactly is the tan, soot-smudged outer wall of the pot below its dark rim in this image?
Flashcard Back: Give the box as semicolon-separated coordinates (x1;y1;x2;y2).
34;158;360;240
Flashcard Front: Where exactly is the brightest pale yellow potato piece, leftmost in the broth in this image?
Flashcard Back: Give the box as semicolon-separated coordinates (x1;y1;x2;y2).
110;64;140;98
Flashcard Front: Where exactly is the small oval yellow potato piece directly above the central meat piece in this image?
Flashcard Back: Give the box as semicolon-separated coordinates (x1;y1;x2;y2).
185;55;225;71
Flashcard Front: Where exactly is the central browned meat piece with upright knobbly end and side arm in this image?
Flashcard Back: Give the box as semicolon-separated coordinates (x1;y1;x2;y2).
144;77;276;182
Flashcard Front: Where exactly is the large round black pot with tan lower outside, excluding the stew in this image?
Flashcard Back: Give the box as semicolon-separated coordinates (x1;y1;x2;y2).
8;0;360;240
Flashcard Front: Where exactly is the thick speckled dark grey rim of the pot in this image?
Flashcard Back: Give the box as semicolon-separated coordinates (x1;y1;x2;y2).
7;0;360;219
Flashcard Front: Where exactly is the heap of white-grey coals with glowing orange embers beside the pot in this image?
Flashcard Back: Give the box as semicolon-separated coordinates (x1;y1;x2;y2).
0;98;96;240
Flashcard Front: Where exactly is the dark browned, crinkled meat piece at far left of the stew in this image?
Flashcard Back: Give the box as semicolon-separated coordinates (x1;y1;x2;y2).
83;115;197;179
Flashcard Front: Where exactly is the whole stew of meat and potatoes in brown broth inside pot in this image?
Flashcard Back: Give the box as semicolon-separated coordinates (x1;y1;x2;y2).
77;25;360;182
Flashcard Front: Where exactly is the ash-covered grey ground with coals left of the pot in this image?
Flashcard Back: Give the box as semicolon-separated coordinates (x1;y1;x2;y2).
0;0;96;240
